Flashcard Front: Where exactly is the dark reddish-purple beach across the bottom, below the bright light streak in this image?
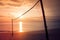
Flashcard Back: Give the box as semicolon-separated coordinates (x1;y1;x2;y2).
0;29;60;40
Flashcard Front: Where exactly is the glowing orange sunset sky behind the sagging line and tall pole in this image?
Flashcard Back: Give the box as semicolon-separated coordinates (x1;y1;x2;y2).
0;0;59;18
